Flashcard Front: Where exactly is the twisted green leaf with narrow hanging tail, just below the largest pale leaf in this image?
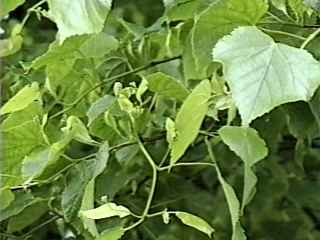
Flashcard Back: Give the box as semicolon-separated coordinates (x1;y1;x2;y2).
219;126;268;211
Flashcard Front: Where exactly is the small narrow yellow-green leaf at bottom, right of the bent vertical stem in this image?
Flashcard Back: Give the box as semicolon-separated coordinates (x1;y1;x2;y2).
175;212;214;238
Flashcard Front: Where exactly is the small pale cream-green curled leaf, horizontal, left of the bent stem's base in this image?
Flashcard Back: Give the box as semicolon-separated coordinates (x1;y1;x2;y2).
81;203;131;219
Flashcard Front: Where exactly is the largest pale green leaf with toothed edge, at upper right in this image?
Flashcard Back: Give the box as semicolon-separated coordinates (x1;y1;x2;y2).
213;27;320;125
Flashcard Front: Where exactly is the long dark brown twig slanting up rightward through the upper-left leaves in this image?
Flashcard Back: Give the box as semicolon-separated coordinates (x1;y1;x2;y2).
50;56;181;119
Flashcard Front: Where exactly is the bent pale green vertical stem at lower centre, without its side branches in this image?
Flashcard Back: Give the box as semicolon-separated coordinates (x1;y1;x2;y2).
138;138;158;217
